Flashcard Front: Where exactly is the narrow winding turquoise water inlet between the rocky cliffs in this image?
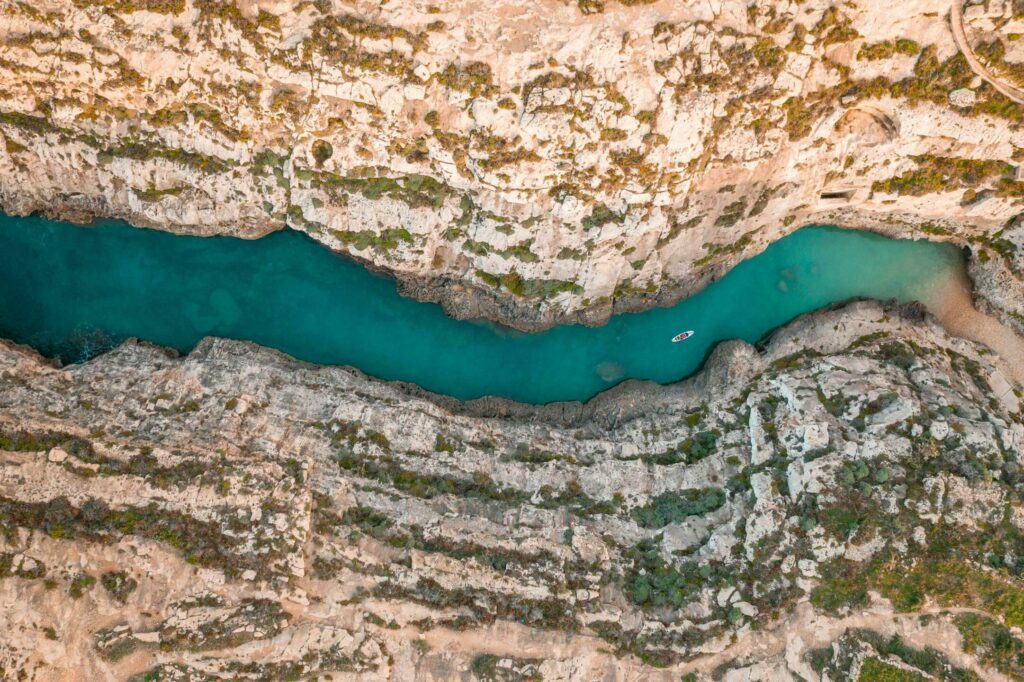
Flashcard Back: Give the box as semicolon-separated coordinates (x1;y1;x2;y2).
0;217;962;402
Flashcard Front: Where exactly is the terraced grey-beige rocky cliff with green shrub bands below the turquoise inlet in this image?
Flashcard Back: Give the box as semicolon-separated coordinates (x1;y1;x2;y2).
0;303;1024;680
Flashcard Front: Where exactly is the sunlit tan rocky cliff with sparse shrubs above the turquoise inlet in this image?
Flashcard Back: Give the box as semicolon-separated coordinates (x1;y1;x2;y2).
0;0;1024;329
